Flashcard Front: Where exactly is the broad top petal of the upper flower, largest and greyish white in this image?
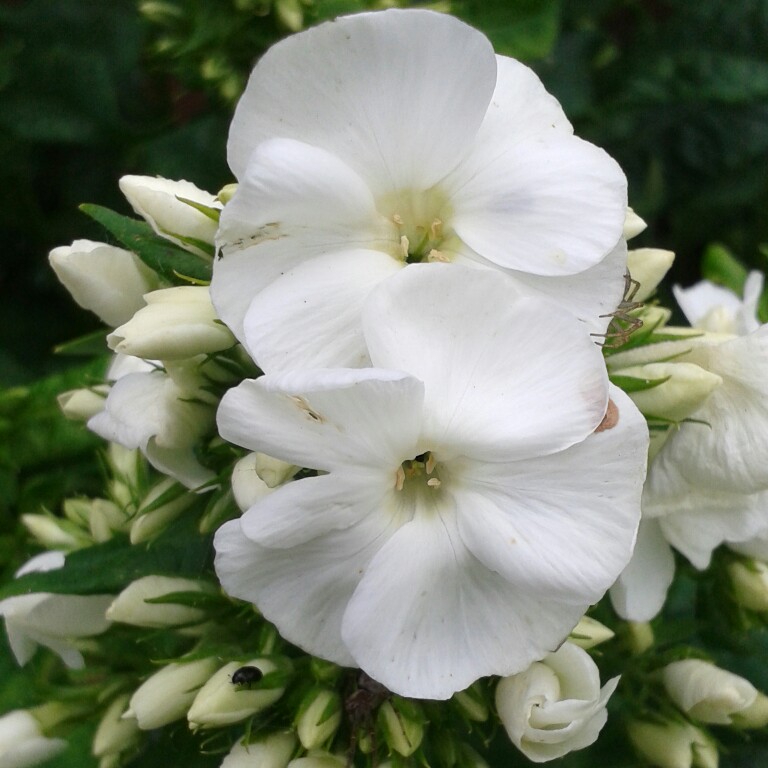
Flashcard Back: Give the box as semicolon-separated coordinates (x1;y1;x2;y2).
228;10;496;192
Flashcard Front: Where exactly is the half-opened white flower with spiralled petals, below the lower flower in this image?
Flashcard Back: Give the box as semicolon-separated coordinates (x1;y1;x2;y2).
496;643;619;763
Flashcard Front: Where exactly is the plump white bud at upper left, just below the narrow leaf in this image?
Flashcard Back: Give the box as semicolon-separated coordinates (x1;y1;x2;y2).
48;240;159;328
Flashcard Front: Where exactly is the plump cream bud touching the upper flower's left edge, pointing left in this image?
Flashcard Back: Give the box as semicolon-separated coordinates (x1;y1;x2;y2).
107;285;235;360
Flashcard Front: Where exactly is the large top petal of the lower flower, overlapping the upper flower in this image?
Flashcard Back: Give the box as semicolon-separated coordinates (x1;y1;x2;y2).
363;264;608;461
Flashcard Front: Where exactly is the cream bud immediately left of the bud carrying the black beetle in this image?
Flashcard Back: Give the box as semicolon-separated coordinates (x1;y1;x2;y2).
124;657;219;731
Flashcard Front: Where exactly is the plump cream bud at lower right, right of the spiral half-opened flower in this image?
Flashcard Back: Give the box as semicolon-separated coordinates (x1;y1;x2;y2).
662;659;757;725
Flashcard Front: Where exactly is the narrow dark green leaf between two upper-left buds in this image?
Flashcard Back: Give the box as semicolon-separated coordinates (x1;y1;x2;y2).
80;203;211;284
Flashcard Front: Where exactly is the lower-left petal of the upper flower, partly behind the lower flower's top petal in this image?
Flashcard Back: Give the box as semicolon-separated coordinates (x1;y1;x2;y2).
244;250;403;373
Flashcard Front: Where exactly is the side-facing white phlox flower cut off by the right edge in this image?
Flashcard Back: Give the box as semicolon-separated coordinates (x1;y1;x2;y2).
611;272;768;621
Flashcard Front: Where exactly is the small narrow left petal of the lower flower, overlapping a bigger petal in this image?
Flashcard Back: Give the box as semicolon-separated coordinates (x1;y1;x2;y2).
240;471;395;557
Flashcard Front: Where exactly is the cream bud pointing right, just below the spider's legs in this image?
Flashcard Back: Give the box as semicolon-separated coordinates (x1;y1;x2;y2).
613;362;723;422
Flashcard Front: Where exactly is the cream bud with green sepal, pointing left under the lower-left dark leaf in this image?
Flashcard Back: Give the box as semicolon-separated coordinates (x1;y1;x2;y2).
107;576;213;628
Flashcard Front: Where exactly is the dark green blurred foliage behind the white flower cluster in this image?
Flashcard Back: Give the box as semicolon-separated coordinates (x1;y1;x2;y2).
0;0;768;768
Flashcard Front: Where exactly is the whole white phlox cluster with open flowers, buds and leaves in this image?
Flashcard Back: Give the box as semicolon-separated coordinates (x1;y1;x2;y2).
0;10;768;768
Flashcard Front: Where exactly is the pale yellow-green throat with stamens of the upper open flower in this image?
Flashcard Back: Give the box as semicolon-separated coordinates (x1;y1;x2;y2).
376;188;455;264
